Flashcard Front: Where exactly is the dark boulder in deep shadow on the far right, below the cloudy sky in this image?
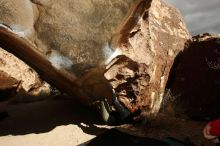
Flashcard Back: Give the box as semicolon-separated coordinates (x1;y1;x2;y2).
167;34;220;119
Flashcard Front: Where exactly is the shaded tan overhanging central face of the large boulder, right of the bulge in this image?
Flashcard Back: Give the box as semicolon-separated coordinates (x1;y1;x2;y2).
33;0;137;66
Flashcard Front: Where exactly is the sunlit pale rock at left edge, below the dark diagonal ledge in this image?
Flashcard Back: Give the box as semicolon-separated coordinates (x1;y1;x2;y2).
0;48;50;96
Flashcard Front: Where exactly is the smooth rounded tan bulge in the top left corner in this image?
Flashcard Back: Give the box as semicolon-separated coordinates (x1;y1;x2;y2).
0;0;35;36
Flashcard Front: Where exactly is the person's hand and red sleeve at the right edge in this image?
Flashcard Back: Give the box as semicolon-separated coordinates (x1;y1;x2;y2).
203;119;220;143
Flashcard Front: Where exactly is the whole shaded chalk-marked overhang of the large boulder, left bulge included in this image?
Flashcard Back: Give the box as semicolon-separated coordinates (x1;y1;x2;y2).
0;0;139;100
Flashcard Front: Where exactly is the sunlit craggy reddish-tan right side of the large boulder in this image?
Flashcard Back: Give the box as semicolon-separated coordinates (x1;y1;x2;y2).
105;0;190;119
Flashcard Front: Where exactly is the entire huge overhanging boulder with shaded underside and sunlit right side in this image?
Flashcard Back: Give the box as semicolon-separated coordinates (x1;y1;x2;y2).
0;0;191;120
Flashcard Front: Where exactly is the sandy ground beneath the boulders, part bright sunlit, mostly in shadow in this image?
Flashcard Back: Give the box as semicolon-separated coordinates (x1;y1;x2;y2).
0;98;213;146
